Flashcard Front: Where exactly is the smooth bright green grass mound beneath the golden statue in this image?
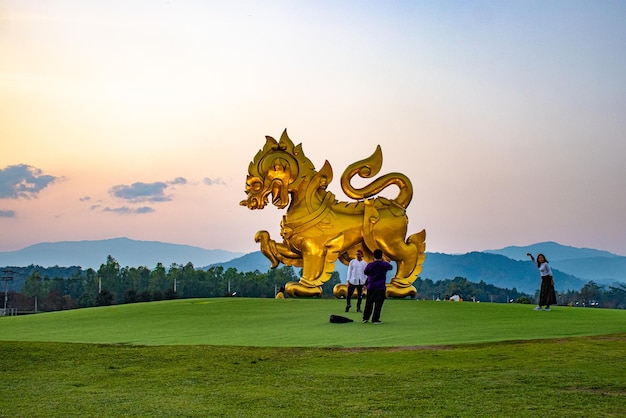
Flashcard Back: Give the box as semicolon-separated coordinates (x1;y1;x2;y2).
0;298;626;347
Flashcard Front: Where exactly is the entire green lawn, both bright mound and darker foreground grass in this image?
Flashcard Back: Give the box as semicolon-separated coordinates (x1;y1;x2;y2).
0;298;626;417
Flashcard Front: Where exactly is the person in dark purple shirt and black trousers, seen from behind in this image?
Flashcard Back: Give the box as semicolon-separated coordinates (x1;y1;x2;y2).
363;249;393;324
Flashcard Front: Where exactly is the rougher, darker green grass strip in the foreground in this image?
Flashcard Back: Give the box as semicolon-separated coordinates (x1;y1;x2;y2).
0;334;626;418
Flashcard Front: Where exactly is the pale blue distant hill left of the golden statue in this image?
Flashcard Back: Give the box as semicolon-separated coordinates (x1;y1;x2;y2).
0;238;244;270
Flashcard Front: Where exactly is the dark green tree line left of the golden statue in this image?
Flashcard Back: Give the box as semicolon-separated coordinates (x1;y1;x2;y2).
10;256;341;312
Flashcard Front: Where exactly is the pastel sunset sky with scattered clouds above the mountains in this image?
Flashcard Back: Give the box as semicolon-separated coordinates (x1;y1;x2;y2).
0;0;626;255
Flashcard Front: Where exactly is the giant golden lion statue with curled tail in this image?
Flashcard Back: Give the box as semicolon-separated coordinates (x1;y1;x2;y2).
240;130;426;298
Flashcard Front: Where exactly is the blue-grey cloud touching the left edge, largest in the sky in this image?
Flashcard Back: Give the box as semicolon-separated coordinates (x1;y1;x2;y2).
0;164;59;199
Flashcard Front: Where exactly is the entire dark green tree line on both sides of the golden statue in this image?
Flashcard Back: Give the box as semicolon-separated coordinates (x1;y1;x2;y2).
2;256;626;312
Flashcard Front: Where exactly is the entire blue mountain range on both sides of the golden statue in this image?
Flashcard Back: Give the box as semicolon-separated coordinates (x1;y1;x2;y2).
0;238;626;294
